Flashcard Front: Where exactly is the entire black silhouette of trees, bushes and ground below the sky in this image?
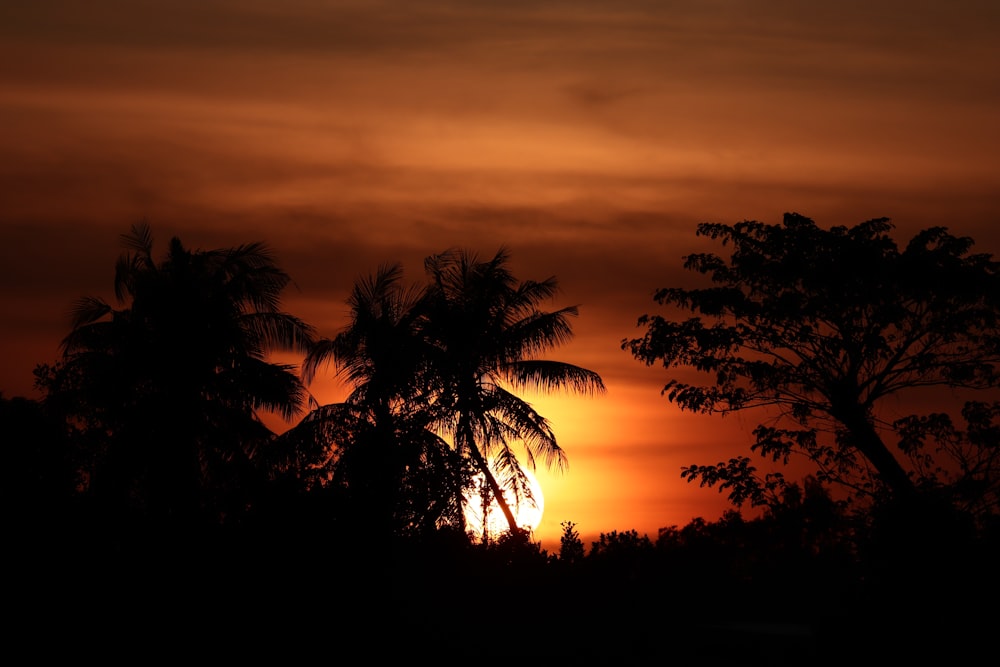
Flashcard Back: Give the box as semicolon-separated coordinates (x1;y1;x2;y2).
7;216;1000;664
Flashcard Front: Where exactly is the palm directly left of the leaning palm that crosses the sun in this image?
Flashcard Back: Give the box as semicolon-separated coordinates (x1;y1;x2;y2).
293;264;460;536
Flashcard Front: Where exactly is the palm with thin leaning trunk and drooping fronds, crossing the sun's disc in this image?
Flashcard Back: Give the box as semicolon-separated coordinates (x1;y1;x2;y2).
422;248;604;534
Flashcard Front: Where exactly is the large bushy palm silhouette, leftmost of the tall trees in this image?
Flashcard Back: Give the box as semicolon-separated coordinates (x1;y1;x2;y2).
37;223;312;522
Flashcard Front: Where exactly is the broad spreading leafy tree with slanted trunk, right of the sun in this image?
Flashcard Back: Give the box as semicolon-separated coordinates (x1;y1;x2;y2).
622;213;1000;516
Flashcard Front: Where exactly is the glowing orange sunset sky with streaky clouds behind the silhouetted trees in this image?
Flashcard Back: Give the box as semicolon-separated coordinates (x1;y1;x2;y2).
0;0;1000;548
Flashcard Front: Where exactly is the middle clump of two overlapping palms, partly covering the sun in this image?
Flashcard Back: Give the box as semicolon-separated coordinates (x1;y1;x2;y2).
297;250;604;532
